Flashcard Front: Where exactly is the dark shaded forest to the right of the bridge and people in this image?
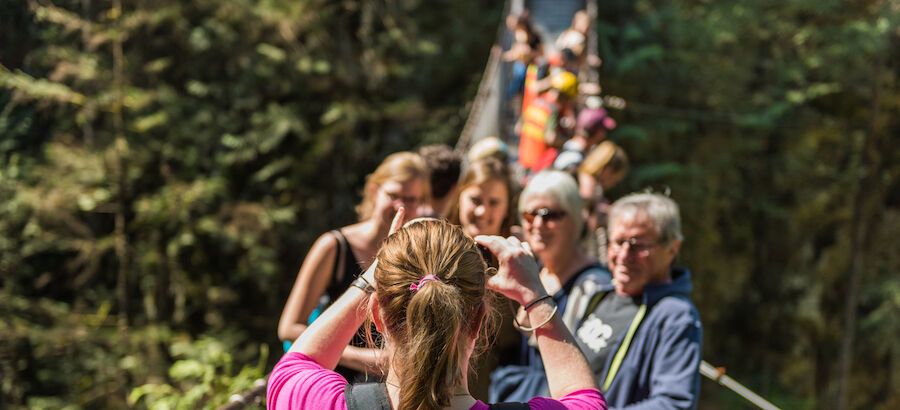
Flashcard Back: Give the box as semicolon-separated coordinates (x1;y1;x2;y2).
598;0;900;408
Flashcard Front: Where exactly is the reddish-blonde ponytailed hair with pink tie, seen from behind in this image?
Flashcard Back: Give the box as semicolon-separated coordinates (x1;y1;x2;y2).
375;220;493;409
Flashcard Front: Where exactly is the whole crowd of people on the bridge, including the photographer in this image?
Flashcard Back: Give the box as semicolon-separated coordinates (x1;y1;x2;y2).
267;8;701;409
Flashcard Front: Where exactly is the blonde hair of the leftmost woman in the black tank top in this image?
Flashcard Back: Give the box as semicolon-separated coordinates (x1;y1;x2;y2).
356;151;431;221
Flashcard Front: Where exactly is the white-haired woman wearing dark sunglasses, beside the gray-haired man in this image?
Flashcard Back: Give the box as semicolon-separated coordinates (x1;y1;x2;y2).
489;170;610;401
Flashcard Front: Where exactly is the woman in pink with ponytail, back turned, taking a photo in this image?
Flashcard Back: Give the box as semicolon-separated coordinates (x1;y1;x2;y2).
267;209;606;410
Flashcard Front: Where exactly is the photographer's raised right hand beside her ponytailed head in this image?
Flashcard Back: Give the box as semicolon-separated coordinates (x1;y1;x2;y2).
475;235;547;304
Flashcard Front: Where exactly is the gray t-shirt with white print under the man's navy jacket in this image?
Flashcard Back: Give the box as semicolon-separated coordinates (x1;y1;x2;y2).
575;291;641;378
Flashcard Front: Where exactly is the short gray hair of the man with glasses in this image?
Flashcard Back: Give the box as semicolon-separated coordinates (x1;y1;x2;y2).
609;192;683;243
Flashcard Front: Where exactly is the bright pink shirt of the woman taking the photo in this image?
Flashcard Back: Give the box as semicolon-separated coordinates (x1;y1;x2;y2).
266;353;606;410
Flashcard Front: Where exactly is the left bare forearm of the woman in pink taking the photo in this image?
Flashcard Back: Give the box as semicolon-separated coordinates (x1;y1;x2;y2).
290;286;369;369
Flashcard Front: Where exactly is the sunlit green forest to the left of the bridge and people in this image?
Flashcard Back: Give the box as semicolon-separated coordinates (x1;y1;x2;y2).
0;0;501;408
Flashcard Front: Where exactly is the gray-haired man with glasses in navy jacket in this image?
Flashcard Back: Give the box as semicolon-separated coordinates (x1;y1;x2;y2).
575;193;701;409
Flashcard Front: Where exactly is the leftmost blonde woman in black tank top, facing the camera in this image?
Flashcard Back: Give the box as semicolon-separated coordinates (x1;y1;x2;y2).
278;152;429;381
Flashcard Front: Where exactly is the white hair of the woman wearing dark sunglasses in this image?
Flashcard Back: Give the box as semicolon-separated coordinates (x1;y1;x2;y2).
519;170;584;229
